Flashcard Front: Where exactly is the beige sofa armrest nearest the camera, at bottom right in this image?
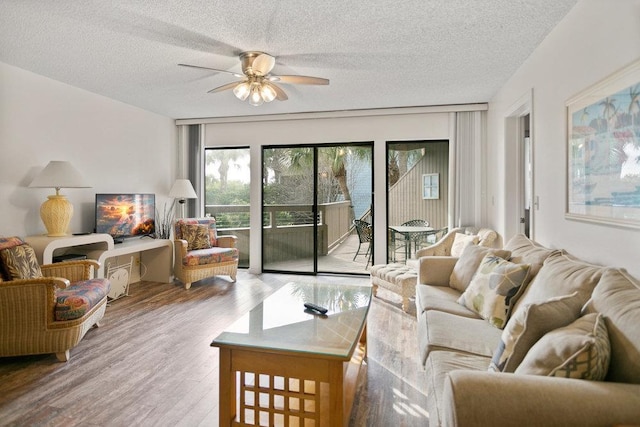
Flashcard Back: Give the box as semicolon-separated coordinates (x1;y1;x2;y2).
442;370;640;426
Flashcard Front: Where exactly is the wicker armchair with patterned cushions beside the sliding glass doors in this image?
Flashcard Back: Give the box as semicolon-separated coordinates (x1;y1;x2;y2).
173;217;238;289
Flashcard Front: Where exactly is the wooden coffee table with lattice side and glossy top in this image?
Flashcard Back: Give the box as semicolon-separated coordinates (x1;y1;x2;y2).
211;283;371;426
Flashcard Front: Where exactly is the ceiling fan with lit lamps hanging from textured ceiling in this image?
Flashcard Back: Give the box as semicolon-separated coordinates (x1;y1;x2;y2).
178;51;329;106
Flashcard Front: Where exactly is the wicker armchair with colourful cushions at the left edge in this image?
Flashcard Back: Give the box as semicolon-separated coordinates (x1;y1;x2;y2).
0;239;109;362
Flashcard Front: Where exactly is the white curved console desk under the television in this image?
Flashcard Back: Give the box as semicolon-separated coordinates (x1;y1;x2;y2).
25;233;173;283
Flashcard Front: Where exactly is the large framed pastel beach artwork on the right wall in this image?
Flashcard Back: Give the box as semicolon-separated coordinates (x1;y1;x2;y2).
565;60;640;228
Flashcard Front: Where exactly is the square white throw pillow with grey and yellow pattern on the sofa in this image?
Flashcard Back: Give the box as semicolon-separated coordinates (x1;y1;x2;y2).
458;254;529;329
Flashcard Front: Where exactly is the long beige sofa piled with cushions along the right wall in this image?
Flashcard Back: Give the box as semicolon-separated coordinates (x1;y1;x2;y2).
416;235;640;427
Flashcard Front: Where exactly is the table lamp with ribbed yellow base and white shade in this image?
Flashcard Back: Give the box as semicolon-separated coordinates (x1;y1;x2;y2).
29;160;91;237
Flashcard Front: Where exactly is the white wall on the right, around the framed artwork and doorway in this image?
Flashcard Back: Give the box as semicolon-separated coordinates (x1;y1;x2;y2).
487;0;640;277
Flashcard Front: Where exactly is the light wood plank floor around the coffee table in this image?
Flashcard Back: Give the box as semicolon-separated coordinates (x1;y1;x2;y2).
0;271;428;426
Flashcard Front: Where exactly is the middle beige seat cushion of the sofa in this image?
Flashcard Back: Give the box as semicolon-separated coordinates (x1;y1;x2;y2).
426;310;501;357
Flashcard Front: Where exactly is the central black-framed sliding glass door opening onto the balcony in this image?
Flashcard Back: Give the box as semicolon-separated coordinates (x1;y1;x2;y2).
262;143;372;274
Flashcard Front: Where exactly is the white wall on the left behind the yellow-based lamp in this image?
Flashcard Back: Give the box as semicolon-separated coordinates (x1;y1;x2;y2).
0;63;177;236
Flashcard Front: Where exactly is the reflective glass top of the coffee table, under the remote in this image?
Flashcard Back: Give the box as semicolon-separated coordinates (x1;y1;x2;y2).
211;283;371;358
